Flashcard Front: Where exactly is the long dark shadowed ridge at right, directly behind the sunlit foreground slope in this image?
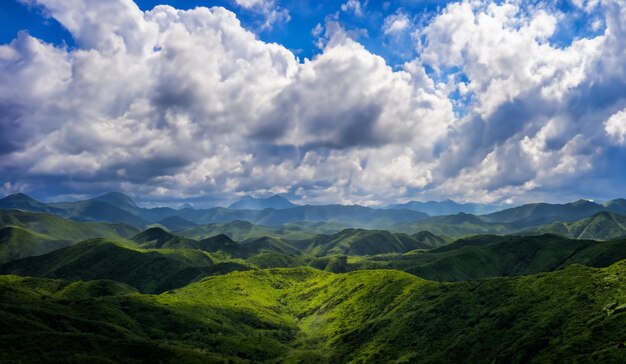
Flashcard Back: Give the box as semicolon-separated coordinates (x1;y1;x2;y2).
349;234;626;281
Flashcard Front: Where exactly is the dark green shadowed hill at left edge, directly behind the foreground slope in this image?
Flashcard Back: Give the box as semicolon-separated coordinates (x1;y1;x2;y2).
0;239;222;293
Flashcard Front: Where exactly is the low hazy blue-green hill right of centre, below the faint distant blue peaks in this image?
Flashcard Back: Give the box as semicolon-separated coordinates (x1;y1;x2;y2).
388;212;517;237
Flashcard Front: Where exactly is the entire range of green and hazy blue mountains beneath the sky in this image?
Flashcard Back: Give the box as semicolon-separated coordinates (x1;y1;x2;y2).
0;193;626;363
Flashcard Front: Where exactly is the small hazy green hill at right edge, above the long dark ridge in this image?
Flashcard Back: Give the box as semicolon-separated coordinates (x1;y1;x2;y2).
523;212;626;240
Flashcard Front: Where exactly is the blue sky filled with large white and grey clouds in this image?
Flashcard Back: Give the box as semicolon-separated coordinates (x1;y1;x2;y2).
0;0;626;207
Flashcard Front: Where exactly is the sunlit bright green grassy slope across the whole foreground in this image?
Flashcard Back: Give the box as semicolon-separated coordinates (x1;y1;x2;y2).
0;262;626;363
